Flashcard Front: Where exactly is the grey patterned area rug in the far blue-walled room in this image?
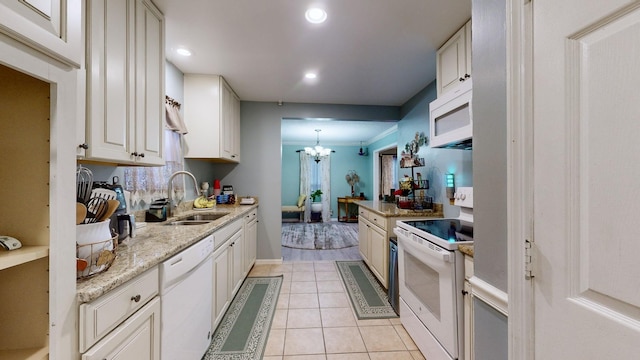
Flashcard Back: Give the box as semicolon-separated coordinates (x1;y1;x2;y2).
282;221;358;250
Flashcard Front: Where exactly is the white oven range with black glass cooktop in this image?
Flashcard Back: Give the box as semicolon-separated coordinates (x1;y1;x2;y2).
393;187;473;360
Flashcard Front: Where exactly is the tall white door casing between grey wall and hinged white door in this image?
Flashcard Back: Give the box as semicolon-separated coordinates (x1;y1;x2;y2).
508;0;535;360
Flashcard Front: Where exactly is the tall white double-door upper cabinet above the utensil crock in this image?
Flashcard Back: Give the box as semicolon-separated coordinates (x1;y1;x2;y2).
84;0;165;165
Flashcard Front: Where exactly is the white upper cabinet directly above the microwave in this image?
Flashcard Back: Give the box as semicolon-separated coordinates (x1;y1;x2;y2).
436;20;471;97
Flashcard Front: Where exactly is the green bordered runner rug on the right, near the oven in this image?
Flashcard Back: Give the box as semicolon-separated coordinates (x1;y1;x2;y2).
336;261;398;320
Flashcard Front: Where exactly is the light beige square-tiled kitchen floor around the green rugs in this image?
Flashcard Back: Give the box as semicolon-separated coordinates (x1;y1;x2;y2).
249;261;424;360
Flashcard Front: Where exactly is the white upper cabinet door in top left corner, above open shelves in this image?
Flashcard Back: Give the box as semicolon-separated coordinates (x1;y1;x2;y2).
0;0;82;68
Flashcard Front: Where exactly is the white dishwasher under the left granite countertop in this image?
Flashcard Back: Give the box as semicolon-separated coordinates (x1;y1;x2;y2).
160;235;213;360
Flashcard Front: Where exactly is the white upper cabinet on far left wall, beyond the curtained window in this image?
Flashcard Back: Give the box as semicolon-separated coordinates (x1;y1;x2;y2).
184;74;240;163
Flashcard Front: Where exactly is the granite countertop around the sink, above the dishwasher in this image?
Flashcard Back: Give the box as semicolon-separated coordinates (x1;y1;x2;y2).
76;203;258;303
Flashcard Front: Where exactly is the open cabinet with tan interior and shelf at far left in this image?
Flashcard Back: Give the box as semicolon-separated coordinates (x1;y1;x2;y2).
0;65;50;359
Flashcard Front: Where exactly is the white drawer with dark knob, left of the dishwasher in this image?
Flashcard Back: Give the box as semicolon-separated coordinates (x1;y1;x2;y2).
79;267;158;352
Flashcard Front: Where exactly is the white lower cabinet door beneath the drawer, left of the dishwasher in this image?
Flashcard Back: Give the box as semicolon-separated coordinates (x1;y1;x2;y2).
82;297;160;360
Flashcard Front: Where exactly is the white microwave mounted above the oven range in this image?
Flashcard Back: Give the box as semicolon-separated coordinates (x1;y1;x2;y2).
429;79;473;150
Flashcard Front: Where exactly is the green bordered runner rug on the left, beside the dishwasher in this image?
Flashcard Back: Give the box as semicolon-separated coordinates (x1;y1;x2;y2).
202;276;282;360
